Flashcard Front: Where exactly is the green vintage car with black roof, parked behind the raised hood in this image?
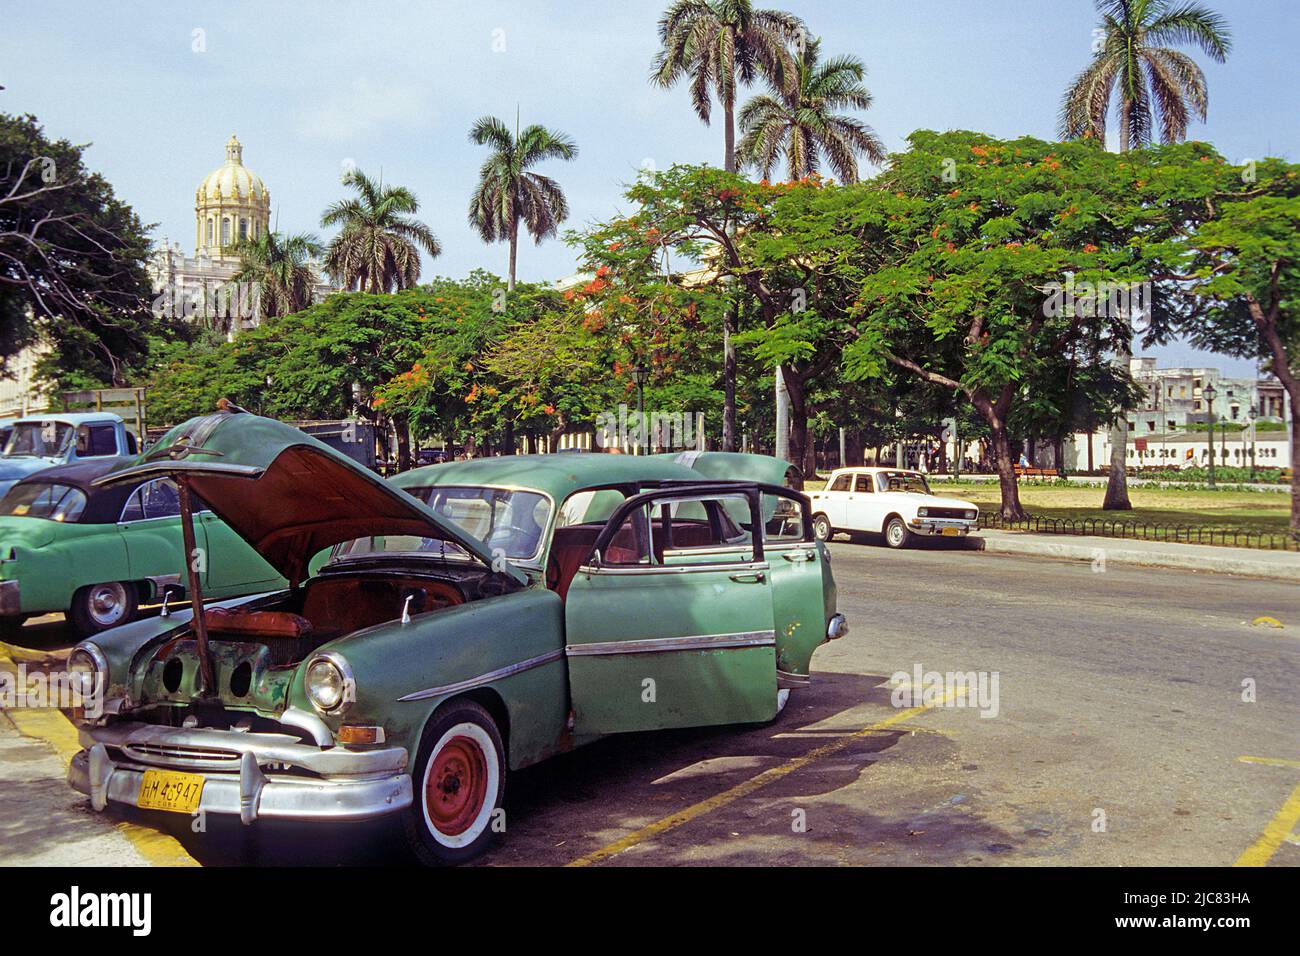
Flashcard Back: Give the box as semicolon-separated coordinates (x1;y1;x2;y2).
0;457;285;636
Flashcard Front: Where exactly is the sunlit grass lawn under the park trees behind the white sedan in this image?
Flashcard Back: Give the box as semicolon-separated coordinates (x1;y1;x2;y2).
806;481;1291;533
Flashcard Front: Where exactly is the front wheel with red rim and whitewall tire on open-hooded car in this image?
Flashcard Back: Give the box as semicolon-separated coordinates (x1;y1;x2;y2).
404;701;506;866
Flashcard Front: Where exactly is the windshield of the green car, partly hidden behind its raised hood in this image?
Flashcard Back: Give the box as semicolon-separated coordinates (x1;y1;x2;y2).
332;485;551;561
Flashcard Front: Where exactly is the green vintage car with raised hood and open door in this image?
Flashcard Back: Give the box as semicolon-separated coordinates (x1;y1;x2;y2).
69;412;845;864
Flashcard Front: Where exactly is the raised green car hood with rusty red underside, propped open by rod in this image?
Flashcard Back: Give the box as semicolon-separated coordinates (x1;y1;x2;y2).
95;411;527;584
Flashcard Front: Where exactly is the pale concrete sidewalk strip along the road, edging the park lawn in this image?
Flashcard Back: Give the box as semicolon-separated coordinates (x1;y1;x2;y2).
967;531;1300;584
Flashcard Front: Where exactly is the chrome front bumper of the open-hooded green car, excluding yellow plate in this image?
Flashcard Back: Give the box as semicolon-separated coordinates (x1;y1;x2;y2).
68;722;412;825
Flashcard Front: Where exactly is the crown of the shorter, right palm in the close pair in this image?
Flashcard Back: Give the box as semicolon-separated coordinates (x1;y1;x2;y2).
740;40;885;182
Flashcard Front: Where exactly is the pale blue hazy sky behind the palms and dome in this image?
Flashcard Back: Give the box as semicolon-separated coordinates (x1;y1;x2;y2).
0;0;1300;375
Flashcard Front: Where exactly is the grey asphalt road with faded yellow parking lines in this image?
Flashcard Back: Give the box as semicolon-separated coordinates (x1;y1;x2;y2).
2;542;1300;866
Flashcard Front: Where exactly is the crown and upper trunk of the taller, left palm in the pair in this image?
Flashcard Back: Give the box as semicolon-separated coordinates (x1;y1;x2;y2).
650;0;803;173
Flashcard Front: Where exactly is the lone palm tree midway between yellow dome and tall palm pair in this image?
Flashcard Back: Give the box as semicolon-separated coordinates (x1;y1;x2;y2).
469;116;577;291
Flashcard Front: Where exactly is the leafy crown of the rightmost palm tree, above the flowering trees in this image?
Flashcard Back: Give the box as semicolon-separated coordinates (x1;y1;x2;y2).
1061;0;1232;151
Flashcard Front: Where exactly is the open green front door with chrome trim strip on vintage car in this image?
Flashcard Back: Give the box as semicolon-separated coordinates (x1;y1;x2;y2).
566;484;776;734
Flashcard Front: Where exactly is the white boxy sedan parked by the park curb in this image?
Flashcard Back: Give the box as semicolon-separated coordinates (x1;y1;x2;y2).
809;468;979;548
